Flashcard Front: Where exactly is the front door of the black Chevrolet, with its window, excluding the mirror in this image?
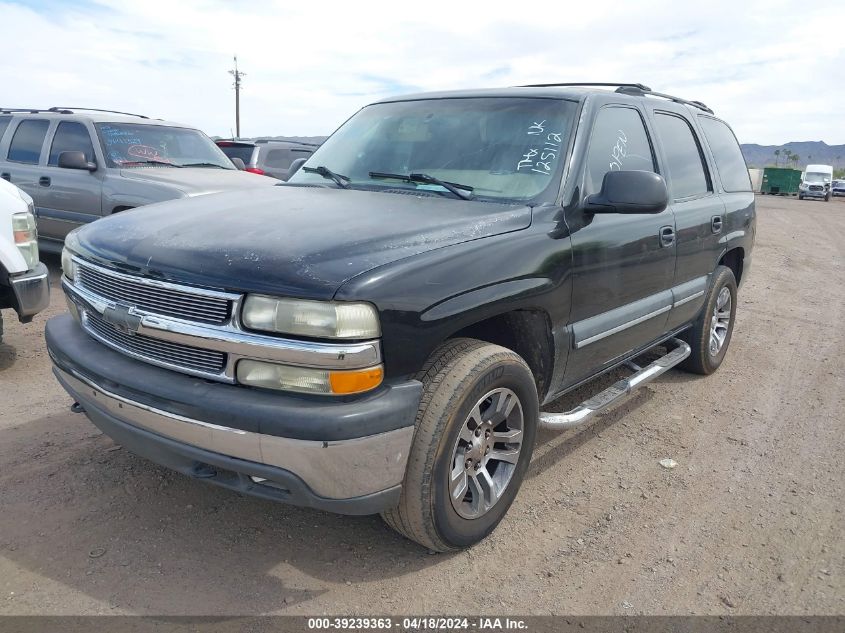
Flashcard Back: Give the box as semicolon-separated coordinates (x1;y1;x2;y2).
566;104;675;385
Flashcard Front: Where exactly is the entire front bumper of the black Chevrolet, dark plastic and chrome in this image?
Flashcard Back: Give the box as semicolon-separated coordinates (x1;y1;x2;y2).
46;315;422;514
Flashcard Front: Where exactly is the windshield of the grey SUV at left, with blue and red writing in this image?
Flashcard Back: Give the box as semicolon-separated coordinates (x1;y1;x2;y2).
96;123;235;169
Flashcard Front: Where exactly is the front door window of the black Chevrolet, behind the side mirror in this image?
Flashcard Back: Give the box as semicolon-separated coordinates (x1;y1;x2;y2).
585;107;654;194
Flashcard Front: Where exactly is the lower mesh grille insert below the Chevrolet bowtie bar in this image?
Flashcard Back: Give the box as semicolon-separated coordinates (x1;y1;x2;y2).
83;311;227;374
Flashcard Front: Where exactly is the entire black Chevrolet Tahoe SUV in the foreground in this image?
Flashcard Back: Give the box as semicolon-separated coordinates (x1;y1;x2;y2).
46;84;755;551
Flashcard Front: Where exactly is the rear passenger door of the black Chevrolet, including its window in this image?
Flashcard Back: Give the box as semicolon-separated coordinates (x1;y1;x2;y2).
649;104;725;330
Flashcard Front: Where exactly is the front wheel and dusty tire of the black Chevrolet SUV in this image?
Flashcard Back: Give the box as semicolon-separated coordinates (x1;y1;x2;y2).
382;338;540;552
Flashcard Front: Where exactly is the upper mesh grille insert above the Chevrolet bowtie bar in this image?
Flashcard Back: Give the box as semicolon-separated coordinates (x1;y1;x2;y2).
76;260;232;324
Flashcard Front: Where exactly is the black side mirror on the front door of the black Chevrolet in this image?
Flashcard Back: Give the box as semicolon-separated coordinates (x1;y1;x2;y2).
584;171;669;213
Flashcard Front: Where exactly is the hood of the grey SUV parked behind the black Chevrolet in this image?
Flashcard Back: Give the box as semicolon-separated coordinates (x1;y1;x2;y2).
120;167;279;196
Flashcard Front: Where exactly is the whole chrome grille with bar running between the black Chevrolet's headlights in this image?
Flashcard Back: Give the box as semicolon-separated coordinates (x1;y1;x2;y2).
62;255;382;384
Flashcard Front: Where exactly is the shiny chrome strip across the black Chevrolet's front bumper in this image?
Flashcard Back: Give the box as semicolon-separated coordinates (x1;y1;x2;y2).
56;367;414;499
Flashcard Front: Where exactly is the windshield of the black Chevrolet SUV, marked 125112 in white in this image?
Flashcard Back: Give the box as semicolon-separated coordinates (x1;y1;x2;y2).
289;97;576;201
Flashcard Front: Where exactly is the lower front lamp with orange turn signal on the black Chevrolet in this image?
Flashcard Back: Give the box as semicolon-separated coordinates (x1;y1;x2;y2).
237;360;384;395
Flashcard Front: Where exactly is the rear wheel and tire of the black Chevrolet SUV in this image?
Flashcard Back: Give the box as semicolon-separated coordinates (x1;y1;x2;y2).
679;266;737;376
